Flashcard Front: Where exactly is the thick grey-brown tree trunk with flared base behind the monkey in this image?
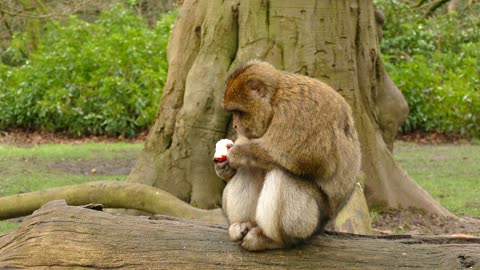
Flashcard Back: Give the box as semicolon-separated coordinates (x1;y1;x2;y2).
128;0;451;215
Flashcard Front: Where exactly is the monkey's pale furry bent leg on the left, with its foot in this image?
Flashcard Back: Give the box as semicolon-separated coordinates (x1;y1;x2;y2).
222;167;265;241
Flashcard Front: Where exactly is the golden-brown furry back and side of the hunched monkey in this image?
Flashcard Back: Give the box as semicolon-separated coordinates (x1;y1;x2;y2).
265;72;361;216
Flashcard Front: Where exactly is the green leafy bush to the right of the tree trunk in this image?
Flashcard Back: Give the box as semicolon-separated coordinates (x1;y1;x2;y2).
376;0;480;137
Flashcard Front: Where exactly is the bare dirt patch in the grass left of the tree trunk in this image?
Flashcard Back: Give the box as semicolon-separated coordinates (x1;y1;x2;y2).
47;159;136;175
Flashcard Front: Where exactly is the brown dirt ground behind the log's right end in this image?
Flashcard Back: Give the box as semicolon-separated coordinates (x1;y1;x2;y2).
372;209;480;236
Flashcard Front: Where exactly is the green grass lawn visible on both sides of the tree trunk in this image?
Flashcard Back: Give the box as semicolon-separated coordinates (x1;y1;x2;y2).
0;139;480;233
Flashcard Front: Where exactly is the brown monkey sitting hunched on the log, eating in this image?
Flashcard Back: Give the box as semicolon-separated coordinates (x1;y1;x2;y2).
215;60;361;251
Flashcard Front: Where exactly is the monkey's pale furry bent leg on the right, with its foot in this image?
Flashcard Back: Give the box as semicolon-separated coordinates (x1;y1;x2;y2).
242;169;325;251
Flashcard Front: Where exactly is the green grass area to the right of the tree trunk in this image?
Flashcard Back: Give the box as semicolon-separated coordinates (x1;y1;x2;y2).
394;142;480;216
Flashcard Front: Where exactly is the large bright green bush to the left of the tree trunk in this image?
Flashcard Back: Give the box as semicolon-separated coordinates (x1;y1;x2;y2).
0;5;176;136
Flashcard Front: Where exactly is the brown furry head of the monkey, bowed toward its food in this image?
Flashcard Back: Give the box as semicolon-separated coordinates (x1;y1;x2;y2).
222;60;278;139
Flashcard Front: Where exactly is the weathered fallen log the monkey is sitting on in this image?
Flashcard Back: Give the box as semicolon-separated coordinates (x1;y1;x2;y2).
0;201;480;269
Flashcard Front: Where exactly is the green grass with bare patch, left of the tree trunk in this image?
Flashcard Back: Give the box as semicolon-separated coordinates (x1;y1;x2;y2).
0;143;143;233
